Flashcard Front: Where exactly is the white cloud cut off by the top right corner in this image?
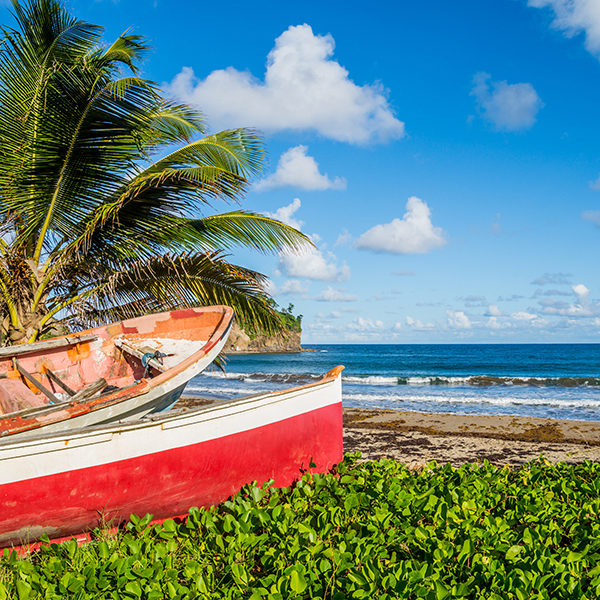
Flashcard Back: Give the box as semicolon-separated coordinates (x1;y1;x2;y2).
527;0;600;58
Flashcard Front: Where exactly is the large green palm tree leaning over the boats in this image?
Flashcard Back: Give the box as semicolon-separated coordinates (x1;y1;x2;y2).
0;0;310;343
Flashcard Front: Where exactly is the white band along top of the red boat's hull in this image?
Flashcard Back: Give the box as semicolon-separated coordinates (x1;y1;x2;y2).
0;376;341;485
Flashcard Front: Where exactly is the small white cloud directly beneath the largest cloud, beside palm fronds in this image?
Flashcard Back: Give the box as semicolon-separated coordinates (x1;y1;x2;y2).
253;146;346;192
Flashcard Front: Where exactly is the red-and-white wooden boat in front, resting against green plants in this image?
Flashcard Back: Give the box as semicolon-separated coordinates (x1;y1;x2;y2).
0;367;343;547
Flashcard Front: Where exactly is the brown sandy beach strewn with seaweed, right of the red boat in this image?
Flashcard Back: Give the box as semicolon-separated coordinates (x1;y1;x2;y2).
344;408;600;466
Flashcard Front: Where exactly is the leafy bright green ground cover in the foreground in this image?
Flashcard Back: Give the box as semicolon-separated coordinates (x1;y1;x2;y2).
0;455;600;600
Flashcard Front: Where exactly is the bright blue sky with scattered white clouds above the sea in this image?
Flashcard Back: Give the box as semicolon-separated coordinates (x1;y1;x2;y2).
0;0;600;343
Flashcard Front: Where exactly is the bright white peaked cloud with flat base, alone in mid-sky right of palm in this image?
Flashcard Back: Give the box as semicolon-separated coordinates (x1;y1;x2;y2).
354;196;446;254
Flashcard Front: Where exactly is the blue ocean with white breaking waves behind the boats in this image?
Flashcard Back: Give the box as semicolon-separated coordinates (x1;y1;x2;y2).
185;344;600;421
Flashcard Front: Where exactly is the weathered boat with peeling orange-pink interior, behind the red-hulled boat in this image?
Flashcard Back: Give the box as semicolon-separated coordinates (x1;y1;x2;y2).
0;306;234;437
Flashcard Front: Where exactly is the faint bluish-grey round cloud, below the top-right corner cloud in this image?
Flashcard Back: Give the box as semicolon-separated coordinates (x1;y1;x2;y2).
471;73;544;131
